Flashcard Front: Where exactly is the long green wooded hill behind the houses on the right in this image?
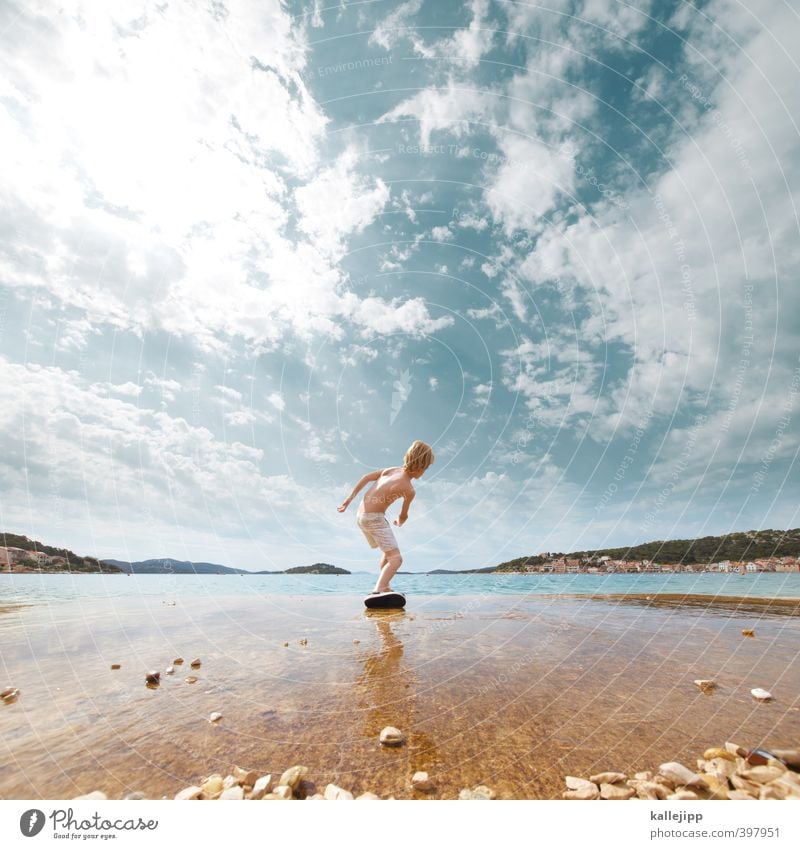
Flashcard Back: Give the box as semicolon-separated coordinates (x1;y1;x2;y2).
497;528;800;572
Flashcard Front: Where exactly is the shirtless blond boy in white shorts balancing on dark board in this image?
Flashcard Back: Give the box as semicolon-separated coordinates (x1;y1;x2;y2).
336;439;433;595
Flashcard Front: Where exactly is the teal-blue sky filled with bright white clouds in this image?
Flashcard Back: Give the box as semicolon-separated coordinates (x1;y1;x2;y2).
0;0;800;571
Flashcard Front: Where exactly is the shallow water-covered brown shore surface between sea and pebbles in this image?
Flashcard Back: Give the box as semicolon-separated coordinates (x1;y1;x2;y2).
0;595;800;799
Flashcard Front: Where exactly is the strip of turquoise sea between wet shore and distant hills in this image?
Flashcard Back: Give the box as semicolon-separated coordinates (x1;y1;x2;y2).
0;572;800;604
